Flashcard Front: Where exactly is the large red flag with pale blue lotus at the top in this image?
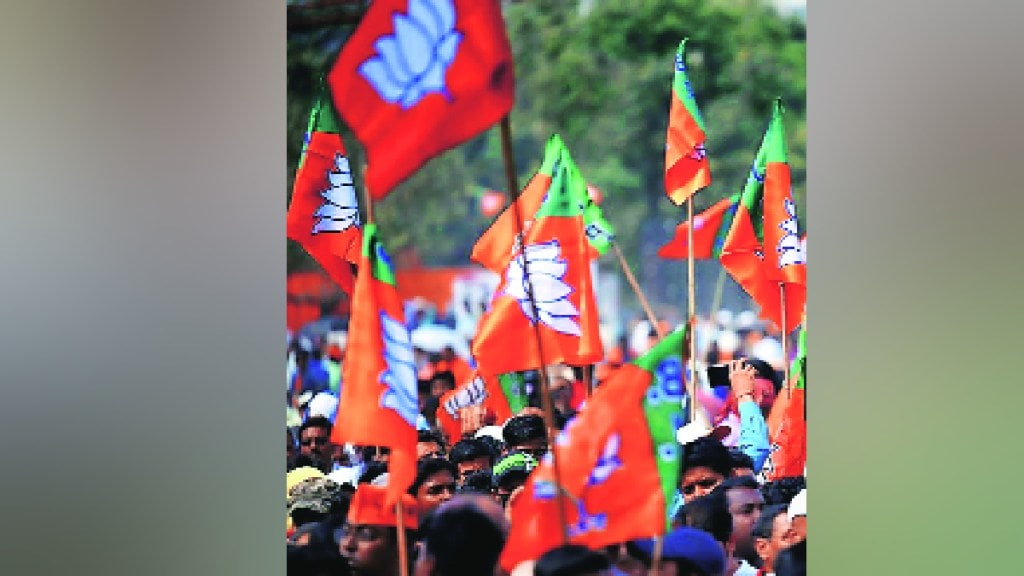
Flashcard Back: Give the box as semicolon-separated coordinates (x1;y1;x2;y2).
328;0;514;199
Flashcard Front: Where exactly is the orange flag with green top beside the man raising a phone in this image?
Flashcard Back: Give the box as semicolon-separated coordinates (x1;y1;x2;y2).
761;326;807;482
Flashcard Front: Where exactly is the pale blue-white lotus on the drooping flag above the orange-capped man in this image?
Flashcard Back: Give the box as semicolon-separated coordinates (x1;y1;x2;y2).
379;313;419;427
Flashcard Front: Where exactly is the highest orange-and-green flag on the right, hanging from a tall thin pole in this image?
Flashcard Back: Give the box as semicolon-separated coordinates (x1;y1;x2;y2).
665;38;711;205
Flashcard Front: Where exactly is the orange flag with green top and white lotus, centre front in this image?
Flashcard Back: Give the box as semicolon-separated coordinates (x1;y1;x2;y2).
473;153;604;374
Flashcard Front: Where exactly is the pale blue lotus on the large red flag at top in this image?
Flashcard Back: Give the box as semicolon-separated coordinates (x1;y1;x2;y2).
359;0;463;110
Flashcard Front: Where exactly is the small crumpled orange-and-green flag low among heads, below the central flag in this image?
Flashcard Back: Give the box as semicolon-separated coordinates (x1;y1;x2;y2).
436;372;527;442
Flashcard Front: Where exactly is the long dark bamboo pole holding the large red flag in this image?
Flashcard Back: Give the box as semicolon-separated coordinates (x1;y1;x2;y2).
501;114;569;544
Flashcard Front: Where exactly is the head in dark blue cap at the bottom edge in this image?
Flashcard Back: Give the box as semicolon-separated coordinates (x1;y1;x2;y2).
631;527;726;576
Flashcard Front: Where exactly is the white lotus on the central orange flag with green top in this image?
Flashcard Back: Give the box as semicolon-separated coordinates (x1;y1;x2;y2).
504;240;583;336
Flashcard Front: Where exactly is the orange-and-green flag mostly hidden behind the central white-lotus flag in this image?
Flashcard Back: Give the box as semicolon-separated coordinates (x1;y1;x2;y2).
469;134;615;274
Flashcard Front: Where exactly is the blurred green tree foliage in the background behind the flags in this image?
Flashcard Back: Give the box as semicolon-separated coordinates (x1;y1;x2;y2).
288;0;806;313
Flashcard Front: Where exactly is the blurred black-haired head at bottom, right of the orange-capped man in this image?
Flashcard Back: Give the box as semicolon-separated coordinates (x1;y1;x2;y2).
420;502;505;576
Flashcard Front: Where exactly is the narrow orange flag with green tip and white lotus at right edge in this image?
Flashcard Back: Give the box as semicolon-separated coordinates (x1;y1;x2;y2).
762;100;807;331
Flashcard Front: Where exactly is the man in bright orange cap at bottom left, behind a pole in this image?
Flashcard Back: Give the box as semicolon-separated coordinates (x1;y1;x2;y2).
338;484;419;576
